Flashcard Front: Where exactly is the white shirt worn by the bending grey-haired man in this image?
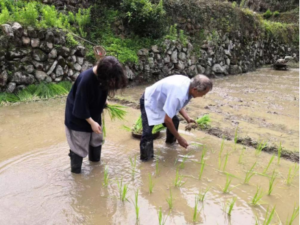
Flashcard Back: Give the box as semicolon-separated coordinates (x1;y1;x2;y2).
145;75;191;126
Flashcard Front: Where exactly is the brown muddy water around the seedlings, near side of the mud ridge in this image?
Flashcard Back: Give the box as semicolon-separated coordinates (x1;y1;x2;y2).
0;69;300;225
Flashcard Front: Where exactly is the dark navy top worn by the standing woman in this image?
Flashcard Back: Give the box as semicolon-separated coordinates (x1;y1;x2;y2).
65;68;108;132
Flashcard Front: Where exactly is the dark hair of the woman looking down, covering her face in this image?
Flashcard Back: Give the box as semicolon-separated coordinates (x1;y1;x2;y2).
96;56;127;96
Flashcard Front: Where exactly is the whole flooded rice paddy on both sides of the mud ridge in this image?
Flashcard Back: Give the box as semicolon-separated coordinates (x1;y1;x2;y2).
0;70;300;225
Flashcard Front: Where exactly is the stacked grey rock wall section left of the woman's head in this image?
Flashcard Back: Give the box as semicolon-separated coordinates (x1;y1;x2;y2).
0;23;92;93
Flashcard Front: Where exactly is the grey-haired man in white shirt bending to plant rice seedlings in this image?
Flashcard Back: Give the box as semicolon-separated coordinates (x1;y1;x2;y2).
140;75;213;161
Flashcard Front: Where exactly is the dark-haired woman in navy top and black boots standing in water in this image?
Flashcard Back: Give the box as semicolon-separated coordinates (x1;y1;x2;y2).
65;56;127;173
